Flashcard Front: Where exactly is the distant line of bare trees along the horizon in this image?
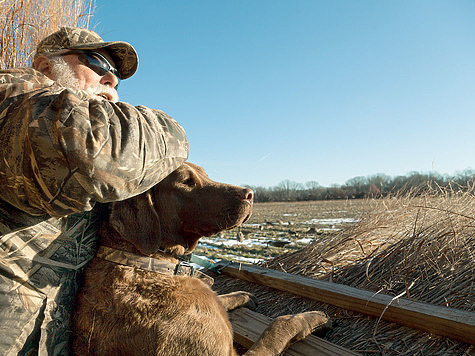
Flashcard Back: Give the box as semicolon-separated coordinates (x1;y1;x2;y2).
246;169;475;202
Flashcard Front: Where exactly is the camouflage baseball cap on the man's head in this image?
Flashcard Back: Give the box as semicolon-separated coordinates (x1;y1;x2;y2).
35;27;139;79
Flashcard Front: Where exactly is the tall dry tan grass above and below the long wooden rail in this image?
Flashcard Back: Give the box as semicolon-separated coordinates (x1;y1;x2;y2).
216;183;475;355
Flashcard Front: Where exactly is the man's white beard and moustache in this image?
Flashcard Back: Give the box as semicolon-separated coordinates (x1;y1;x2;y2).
50;56;119;103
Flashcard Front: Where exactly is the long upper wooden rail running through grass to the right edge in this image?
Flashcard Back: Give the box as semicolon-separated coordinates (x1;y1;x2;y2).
221;263;475;344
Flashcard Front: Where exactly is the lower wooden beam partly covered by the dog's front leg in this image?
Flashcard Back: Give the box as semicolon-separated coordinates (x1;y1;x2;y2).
229;308;358;356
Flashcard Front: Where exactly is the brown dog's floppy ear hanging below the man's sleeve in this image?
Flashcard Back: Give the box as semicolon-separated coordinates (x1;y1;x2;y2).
109;191;161;255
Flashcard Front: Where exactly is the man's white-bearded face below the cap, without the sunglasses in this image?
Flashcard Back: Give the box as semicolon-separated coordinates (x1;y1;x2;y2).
40;50;119;102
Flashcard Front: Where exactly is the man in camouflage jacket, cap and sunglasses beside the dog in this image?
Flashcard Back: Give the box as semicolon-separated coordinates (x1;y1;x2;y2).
0;27;188;355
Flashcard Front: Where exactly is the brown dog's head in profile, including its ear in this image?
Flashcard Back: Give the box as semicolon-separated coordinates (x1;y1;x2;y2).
109;163;254;255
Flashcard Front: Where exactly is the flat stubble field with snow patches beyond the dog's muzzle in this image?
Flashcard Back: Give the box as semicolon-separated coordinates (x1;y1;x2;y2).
195;200;368;263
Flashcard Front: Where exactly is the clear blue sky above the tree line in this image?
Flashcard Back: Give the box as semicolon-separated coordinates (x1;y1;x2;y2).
92;0;475;186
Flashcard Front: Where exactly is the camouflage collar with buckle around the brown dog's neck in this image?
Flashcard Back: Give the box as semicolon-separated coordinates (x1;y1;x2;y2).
96;246;214;287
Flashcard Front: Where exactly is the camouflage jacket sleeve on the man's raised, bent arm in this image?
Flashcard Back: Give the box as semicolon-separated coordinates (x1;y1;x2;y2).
0;68;188;217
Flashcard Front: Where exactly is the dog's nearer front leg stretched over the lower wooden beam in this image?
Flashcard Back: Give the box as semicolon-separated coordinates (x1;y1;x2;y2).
244;311;330;356
